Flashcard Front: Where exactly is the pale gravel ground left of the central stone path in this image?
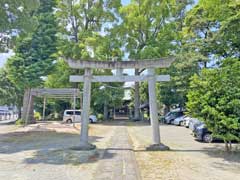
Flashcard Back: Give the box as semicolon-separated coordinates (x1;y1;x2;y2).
0;123;114;180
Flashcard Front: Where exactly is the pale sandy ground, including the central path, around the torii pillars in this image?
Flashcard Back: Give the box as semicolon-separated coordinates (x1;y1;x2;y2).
0;121;240;180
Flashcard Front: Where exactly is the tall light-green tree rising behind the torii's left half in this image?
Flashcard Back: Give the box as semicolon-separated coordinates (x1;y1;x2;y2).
54;0;122;115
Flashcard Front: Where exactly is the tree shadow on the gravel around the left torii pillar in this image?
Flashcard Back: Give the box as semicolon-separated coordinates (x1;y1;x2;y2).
0;130;117;165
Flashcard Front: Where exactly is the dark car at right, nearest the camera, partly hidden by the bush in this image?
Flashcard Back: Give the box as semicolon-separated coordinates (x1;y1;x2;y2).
194;123;213;143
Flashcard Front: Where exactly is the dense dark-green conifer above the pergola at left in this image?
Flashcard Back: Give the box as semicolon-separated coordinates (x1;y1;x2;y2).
6;0;57;118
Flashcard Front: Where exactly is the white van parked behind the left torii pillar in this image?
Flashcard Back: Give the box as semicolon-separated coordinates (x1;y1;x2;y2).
63;109;97;123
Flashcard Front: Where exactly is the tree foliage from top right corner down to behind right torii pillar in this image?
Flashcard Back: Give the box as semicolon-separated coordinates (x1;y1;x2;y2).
159;0;240;112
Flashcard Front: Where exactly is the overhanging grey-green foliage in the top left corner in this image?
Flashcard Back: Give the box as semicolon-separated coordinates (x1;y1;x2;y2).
0;0;39;52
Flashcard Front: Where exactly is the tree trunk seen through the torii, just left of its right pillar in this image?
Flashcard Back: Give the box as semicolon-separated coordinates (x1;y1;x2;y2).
134;69;140;120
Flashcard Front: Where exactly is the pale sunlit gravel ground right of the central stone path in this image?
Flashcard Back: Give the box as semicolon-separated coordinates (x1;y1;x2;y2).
128;124;240;180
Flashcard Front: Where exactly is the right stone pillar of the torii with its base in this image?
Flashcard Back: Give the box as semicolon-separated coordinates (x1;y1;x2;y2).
147;69;170;151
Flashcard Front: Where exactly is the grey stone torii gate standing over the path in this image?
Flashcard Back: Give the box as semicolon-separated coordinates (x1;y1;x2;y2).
67;58;174;150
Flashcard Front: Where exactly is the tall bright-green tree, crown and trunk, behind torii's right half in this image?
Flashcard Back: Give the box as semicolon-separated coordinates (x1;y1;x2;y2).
120;0;192;119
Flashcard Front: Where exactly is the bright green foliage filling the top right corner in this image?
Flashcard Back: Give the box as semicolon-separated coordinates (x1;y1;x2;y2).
183;0;240;64
